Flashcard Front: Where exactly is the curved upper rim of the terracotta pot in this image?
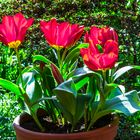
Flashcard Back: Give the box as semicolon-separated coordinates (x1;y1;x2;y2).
13;113;119;138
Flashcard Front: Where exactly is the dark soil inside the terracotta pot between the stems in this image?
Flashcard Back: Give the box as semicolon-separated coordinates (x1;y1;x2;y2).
20;111;114;134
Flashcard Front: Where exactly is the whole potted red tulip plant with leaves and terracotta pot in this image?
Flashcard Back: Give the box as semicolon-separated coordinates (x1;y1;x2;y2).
0;13;140;140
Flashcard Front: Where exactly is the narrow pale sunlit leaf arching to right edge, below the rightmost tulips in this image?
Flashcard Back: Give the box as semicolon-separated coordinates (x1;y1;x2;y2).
113;66;140;81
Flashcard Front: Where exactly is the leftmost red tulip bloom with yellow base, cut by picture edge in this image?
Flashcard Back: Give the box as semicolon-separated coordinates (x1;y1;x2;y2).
0;13;33;49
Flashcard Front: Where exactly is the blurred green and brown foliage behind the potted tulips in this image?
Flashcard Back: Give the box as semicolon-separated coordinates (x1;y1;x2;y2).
0;0;140;140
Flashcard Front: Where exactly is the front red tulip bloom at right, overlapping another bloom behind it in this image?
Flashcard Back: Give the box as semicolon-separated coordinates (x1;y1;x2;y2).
80;40;118;70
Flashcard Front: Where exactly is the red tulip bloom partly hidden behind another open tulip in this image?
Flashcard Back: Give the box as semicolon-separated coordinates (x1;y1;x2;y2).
84;26;118;46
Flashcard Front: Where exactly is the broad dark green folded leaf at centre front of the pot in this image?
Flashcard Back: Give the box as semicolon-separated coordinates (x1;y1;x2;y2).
54;79;91;126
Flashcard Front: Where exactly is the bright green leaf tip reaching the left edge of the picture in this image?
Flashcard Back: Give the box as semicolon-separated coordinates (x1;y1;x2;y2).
0;78;22;97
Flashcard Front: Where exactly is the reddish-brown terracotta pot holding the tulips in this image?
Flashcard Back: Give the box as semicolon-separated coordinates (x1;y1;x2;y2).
13;114;119;140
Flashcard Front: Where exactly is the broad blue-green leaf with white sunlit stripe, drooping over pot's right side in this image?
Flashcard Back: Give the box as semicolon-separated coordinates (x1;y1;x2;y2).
91;90;140;127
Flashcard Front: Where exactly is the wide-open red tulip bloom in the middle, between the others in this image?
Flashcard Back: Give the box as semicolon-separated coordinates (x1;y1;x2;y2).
40;19;84;49
